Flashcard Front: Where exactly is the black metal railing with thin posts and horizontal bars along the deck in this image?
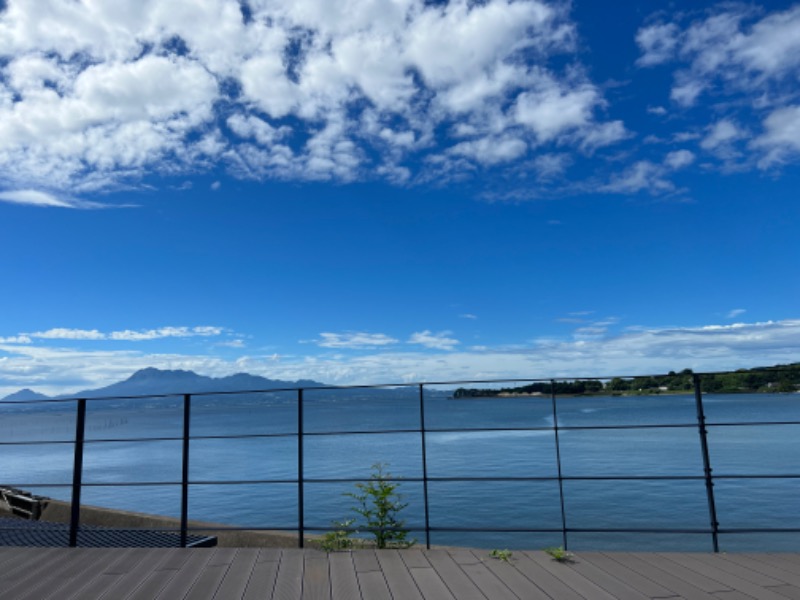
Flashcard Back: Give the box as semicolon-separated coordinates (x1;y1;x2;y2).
0;374;800;552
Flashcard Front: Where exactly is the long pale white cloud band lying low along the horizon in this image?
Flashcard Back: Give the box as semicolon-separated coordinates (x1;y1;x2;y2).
0;319;800;396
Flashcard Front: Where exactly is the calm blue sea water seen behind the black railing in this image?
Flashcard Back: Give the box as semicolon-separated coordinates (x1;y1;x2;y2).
0;390;800;551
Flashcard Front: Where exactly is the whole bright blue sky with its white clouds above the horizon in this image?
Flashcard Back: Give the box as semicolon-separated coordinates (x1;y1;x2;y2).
0;0;800;395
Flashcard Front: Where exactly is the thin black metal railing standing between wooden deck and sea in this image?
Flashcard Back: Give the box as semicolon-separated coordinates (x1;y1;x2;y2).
0;373;800;552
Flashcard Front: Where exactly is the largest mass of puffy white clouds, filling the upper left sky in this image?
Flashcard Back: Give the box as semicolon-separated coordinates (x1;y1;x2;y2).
0;0;627;193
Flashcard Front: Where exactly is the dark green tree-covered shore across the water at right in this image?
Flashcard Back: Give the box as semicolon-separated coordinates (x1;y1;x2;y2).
453;363;800;398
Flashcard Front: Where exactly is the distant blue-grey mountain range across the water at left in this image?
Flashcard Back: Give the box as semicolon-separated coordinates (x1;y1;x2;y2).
2;367;326;402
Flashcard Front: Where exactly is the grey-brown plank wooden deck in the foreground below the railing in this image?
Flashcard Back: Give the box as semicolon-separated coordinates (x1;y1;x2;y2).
0;547;800;600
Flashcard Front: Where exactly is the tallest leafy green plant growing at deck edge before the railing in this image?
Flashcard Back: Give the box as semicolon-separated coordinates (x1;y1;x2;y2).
345;463;416;549
